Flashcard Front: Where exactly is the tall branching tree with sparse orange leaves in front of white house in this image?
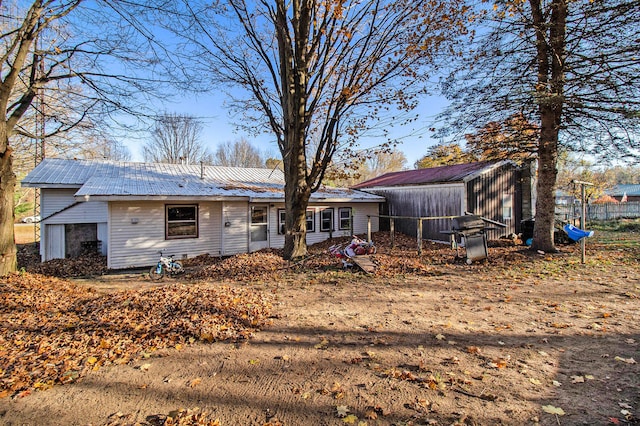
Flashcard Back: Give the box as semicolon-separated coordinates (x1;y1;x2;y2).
148;0;468;258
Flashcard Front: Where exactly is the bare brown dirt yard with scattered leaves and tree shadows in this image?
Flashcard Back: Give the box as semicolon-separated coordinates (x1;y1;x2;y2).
0;226;640;425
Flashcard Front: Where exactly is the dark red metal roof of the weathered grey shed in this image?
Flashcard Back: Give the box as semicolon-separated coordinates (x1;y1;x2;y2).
352;161;500;189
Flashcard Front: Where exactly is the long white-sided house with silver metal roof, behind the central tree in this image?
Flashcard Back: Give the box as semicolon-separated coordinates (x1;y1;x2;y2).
22;158;384;269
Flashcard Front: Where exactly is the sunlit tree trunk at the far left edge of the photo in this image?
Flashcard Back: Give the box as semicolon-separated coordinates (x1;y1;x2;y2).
0;128;17;276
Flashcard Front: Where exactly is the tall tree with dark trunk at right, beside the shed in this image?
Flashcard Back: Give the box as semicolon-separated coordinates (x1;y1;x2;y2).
444;0;640;252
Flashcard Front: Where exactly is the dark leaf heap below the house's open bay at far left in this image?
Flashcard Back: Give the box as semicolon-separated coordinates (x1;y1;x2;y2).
27;253;107;278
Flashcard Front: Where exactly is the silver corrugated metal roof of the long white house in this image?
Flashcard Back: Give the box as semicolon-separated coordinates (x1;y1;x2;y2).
22;158;382;201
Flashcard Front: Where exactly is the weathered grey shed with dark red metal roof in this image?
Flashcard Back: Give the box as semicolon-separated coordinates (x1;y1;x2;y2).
353;160;534;241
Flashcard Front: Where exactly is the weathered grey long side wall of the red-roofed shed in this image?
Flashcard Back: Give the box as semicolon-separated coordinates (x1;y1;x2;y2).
368;183;466;241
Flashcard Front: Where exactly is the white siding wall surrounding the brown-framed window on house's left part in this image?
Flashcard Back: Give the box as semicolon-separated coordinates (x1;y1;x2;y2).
108;201;222;269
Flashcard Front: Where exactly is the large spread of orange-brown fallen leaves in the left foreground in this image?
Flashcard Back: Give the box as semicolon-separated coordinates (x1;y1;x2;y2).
0;273;271;397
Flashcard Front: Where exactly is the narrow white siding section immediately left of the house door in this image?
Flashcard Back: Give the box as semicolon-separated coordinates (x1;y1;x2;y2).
222;201;249;256
